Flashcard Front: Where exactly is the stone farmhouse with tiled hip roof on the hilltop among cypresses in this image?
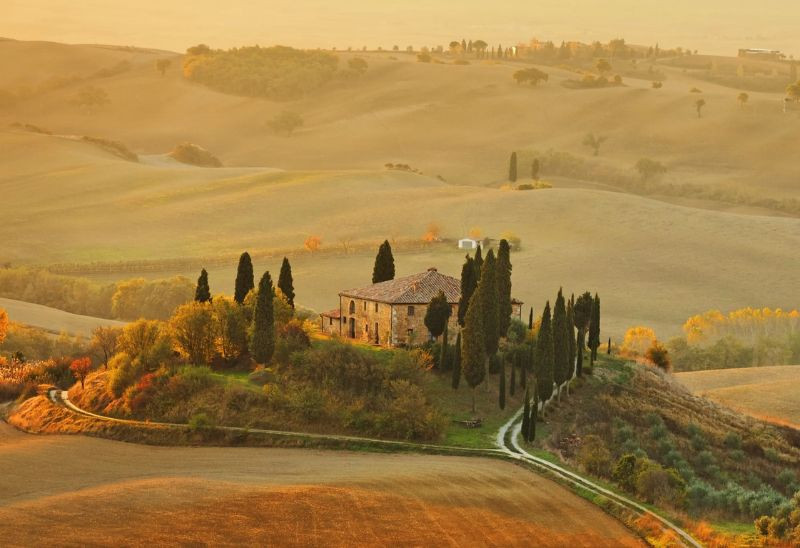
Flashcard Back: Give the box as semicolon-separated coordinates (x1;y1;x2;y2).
320;268;522;348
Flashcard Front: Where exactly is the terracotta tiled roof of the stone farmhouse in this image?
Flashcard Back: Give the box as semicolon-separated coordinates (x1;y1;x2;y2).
339;268;461;304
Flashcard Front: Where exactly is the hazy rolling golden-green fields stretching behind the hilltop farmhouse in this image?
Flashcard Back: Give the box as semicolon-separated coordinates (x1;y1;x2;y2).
0;41;800;339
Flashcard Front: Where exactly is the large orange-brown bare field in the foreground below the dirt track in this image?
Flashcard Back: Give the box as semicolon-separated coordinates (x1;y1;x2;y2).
0;423;642;547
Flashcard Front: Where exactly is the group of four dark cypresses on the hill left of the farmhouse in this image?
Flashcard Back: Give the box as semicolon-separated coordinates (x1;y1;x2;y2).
195;251;295;364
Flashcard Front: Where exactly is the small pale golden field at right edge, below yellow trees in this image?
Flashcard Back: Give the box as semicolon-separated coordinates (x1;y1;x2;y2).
675;365;800;428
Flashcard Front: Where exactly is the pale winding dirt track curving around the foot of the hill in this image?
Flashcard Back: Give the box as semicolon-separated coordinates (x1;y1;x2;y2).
47;389;702;548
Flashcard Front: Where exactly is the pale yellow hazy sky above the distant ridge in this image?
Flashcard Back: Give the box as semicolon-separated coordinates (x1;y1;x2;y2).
0;0;800;54
